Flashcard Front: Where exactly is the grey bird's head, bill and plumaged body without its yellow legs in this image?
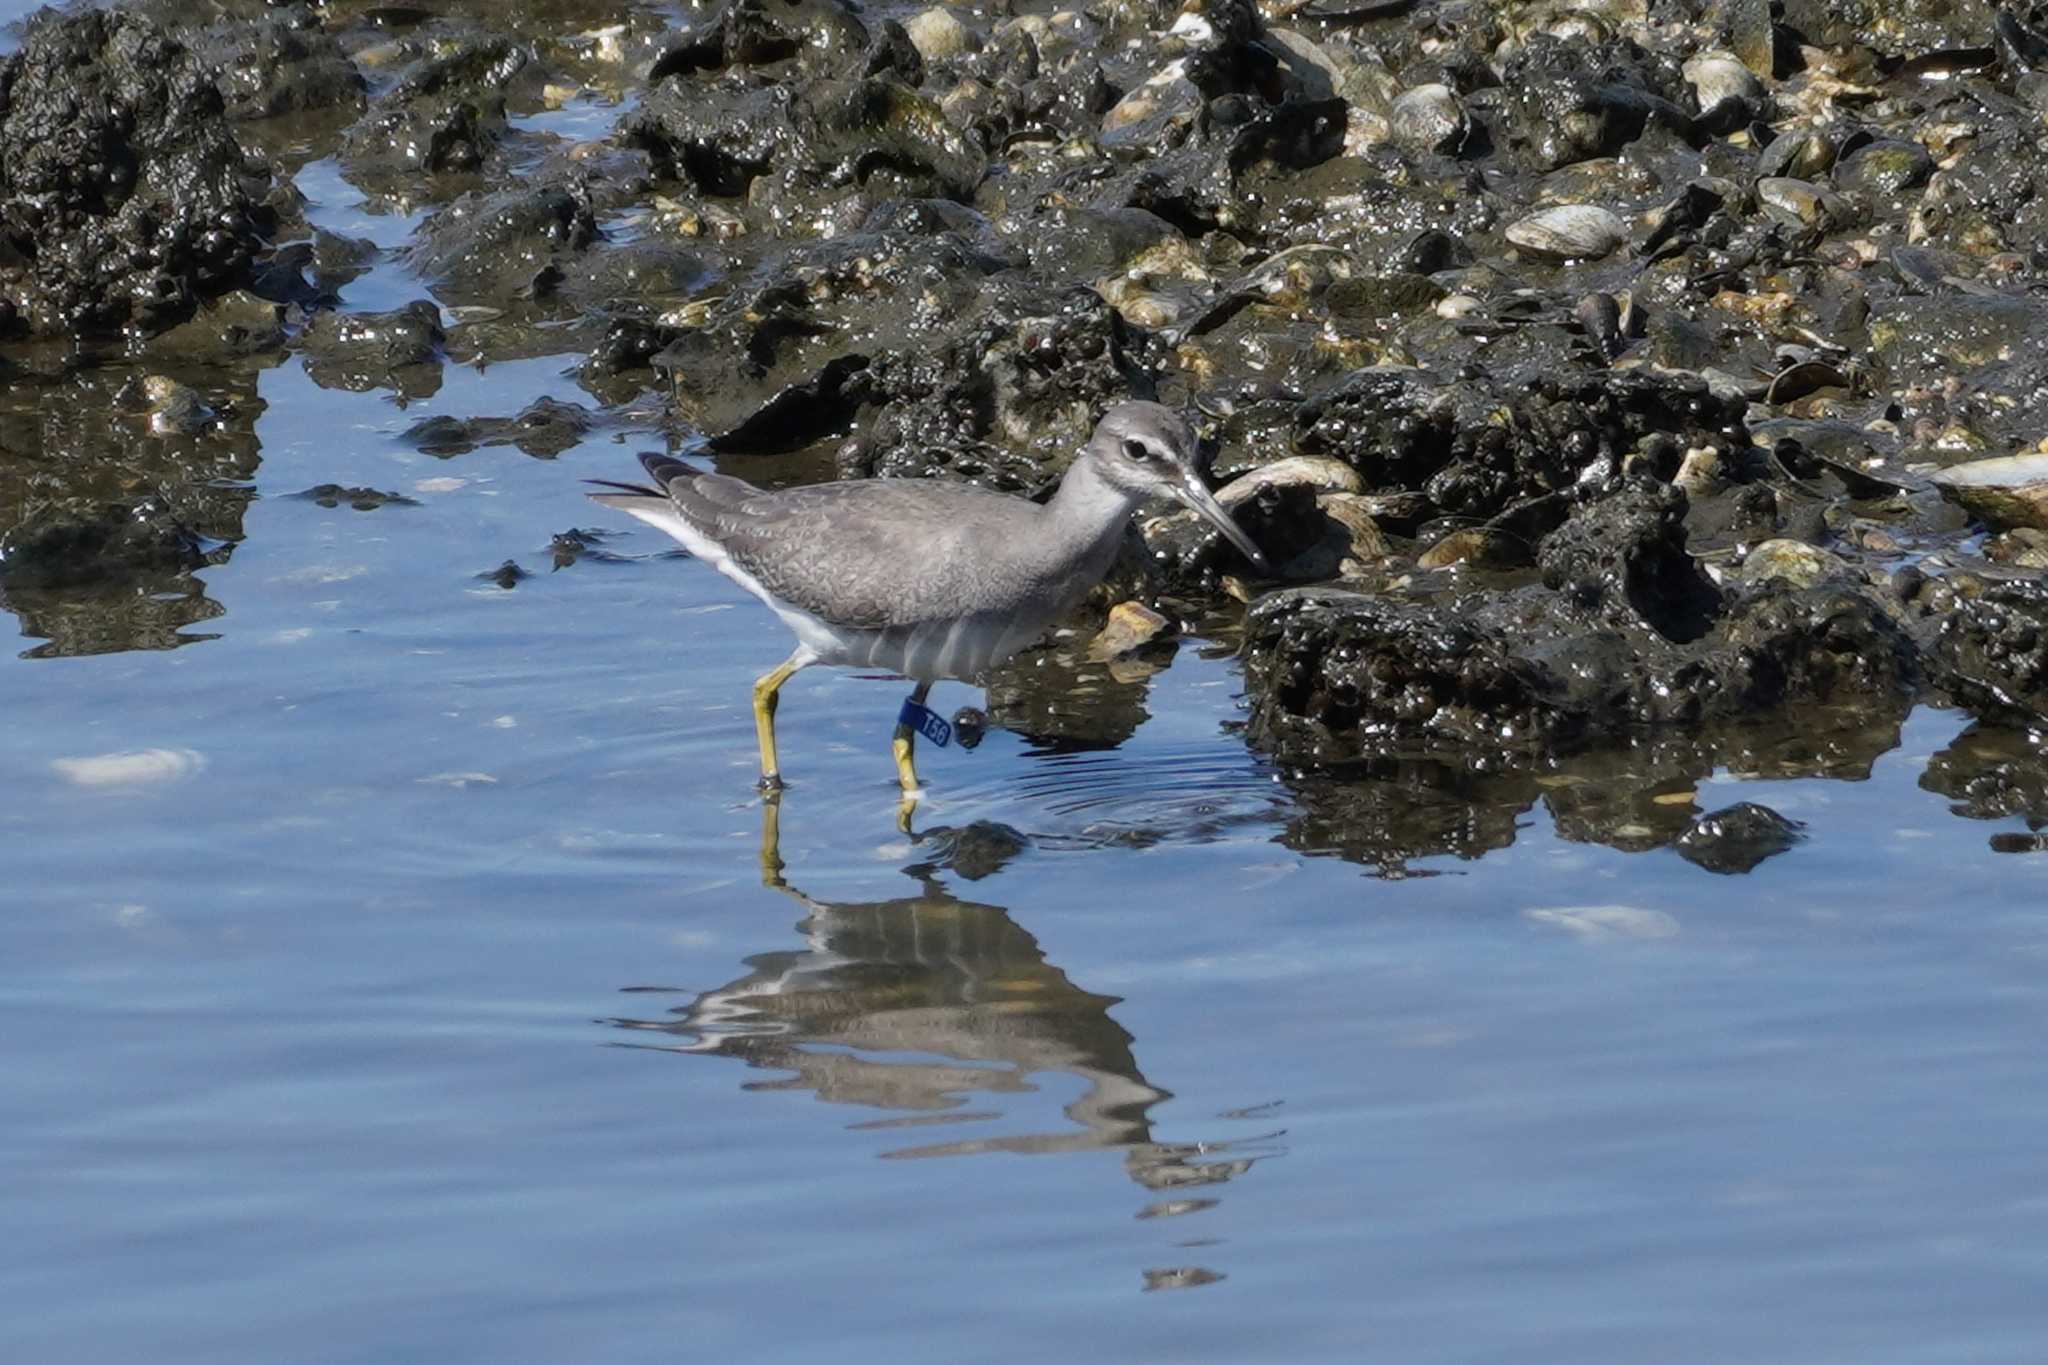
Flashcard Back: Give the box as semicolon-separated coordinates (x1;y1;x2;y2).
592;403;1257;681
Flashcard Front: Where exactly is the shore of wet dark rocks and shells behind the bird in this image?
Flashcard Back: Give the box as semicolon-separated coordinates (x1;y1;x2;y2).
0;0;2048;860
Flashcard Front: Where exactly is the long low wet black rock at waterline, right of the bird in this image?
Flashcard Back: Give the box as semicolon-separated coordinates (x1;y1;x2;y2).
1245;587;1919;763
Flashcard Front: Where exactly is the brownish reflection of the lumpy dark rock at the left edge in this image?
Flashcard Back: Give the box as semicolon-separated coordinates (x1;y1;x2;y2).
0;370;262;657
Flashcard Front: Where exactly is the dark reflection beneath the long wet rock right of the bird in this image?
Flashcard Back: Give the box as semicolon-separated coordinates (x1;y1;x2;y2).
1284;712;1901;874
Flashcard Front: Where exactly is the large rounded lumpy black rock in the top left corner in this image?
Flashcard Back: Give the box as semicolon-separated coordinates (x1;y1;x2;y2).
0;10;276;336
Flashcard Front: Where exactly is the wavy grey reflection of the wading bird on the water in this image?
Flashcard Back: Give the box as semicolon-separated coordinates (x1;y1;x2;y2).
614;802;1280;1287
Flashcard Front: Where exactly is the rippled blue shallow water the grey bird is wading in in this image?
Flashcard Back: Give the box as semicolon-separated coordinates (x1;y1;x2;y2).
12;40;2048;1363
